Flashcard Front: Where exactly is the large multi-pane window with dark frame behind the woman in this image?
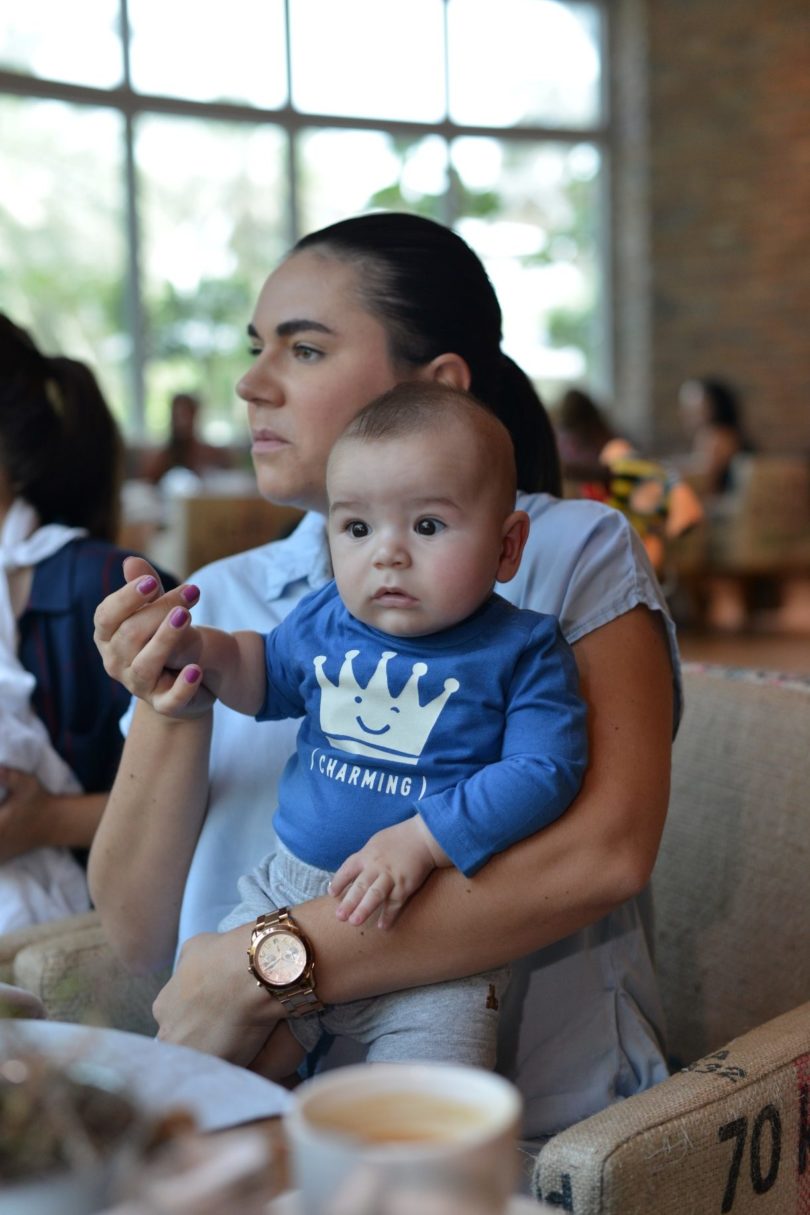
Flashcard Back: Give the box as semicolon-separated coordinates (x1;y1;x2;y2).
0;0;608;441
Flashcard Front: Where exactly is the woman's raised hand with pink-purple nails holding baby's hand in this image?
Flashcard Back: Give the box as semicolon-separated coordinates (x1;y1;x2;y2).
94;556;214;717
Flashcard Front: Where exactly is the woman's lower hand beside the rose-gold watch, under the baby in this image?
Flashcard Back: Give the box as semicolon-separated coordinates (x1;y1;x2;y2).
152;925;284;1067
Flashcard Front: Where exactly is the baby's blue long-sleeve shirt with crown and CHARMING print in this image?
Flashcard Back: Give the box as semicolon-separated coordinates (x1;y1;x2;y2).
257;582;588;874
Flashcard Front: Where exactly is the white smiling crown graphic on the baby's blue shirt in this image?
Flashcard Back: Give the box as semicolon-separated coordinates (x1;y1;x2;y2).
313;650;460;764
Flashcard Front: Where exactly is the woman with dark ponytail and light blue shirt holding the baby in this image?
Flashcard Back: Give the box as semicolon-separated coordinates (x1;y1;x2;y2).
90;214;678;1137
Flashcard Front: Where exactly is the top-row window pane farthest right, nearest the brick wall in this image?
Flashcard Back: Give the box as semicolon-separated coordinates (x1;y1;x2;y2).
448;0;600;126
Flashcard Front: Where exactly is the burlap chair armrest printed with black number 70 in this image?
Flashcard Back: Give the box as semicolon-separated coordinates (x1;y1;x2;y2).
533;1004;810;1215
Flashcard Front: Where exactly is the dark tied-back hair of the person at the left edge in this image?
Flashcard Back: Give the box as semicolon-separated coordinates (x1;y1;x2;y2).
0;313;124;539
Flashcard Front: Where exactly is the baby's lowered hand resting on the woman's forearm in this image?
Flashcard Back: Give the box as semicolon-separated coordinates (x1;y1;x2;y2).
329;814;451;928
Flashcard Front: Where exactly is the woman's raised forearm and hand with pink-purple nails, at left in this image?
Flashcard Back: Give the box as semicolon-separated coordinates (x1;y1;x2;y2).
87;558;218;971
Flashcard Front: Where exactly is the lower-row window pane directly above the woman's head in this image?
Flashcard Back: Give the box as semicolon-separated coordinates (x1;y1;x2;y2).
299;130;447;232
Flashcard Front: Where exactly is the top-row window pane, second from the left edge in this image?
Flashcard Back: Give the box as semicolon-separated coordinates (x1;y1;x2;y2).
129;0;287;108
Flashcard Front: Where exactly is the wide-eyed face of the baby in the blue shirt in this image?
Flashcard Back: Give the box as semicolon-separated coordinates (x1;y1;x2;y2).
327;419;505;637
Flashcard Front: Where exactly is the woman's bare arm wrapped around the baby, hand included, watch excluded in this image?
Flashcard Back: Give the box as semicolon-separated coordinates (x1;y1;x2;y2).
155;608;673;1063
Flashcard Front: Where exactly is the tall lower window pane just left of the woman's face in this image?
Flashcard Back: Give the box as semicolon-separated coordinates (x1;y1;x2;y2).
136;117;288;441
